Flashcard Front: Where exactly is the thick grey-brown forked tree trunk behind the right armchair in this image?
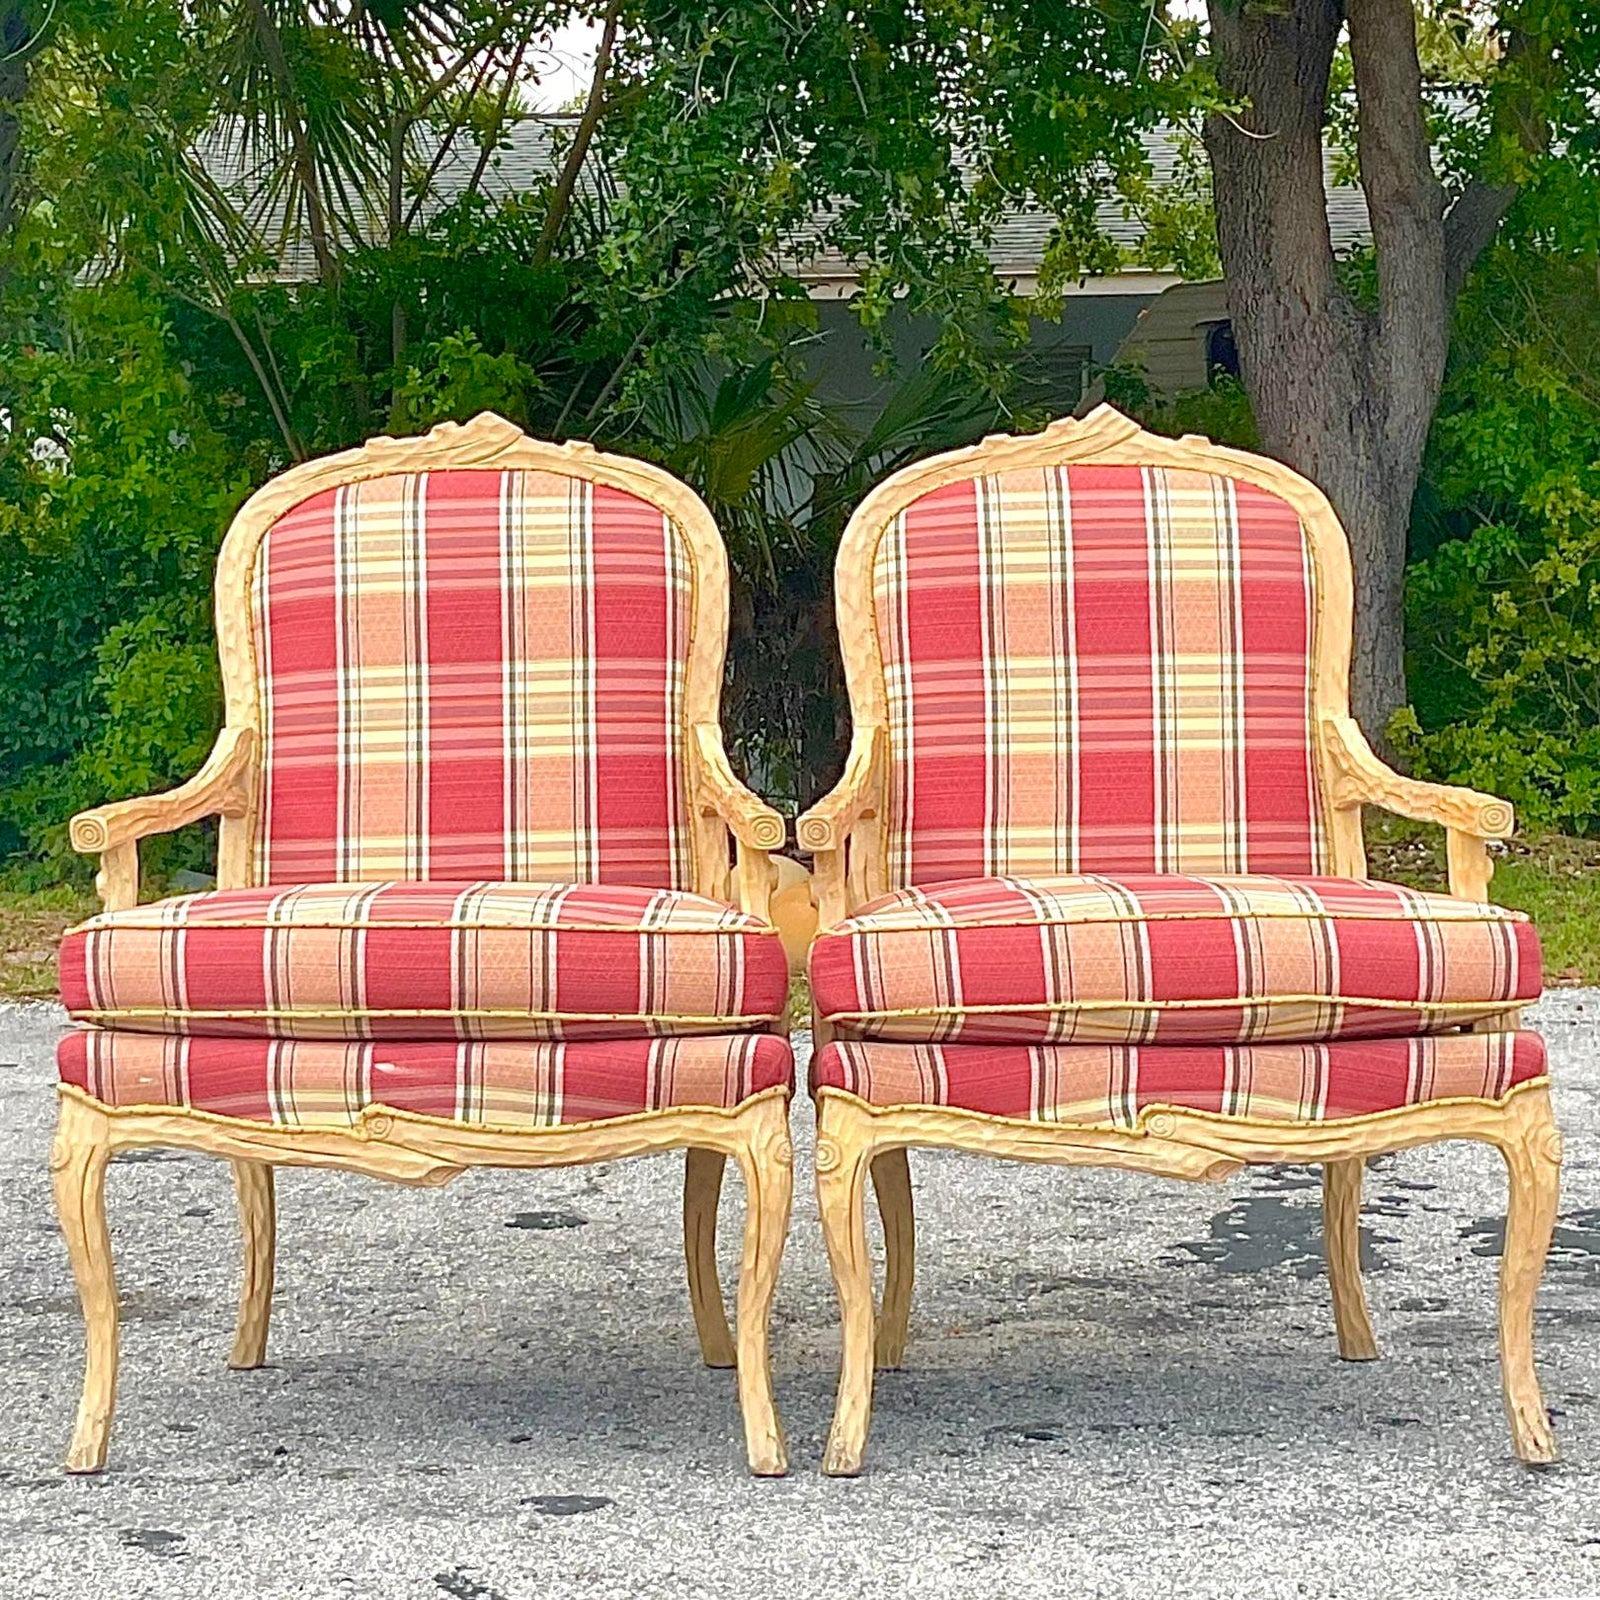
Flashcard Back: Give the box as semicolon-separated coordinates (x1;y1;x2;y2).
1206;0;1450;744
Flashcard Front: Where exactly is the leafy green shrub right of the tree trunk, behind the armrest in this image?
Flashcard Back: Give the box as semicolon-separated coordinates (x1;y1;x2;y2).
1395;242;1600;832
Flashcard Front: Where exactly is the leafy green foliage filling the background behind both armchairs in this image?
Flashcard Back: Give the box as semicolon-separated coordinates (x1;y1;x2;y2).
9;0;1600;870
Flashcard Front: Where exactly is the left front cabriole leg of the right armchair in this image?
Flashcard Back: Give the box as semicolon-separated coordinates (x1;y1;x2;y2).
816;1099;874;1478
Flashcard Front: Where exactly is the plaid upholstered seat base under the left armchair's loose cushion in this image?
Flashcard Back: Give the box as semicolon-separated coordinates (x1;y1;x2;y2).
56;1029;794;1128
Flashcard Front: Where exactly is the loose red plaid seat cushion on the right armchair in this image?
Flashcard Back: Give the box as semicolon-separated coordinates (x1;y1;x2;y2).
811;874;1541;1045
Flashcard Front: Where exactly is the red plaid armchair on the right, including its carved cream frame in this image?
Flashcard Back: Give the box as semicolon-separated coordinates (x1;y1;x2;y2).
797;406;1562;1475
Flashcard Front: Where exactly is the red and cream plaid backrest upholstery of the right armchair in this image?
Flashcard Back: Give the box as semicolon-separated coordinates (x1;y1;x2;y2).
874;466;1326;885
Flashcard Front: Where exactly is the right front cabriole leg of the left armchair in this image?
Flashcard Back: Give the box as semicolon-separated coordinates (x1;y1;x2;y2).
738;1099;794;1478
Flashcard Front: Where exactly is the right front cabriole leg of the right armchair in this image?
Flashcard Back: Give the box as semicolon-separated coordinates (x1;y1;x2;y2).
1496;1090;1562;1466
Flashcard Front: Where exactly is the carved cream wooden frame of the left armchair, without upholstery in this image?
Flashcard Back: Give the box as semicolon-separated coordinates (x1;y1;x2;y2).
50;413;794;1475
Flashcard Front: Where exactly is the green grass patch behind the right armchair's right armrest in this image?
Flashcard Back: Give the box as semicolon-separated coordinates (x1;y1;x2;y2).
1366;811;1600;986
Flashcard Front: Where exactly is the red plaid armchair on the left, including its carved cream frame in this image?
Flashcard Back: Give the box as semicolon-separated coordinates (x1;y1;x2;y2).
51;414;794;1474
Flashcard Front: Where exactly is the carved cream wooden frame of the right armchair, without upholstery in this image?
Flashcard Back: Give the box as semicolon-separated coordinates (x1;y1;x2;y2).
797;405;1562;1477
